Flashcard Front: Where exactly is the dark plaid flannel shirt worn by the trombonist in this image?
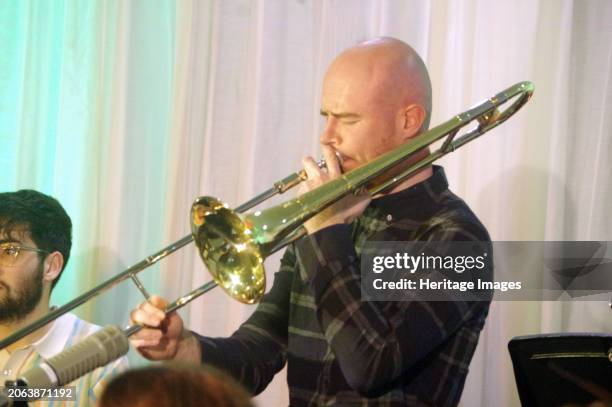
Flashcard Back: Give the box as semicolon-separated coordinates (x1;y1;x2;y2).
199;166;490;406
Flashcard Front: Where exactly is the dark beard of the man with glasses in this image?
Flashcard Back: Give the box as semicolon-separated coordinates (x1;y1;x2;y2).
0;261;44;324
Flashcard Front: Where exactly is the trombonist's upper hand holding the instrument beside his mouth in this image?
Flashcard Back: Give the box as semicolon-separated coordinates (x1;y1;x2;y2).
298;146;372;234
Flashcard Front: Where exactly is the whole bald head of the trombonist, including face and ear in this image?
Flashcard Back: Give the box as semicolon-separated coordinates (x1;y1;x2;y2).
320;38;431;177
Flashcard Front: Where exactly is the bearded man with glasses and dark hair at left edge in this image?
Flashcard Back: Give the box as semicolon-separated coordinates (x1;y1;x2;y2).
0;190;127;406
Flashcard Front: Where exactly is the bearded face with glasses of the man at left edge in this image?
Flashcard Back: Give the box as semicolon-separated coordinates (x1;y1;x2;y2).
0;231;44;323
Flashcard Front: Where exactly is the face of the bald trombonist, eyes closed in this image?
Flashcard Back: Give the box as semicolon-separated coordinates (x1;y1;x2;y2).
320;66;402;172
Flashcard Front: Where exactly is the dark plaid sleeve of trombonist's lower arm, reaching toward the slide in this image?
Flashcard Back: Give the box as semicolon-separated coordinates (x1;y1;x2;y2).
194;247;296;394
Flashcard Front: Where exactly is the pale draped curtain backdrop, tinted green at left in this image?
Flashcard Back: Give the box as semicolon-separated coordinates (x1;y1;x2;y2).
0;0;612;406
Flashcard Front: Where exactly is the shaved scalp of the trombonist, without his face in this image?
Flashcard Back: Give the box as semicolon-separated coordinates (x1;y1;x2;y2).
326;37;431;130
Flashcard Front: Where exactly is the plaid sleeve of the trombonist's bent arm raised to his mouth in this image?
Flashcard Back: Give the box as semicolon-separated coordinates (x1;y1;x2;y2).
296;225;489;396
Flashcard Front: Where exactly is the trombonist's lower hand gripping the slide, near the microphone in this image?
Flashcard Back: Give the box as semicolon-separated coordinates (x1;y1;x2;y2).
130;295;201;363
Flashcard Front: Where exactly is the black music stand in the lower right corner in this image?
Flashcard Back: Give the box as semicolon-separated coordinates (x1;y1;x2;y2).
508;333;612;407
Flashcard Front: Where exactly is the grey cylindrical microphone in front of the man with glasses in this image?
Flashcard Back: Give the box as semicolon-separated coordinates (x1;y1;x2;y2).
18;325;129;388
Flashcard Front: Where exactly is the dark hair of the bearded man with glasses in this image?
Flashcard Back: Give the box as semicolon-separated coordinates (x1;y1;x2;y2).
0;189;72;289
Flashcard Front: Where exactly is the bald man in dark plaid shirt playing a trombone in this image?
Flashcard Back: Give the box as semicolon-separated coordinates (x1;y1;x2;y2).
131;38;489;406
